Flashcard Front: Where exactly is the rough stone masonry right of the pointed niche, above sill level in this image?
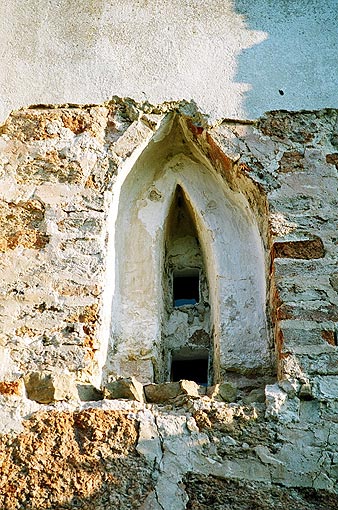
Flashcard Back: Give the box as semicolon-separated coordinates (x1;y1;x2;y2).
206;110;337;385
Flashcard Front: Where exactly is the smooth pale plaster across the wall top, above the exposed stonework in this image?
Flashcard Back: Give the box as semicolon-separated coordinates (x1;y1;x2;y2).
0;0;338;122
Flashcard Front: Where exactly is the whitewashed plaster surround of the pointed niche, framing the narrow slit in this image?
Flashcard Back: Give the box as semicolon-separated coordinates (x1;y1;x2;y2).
107;116;271;382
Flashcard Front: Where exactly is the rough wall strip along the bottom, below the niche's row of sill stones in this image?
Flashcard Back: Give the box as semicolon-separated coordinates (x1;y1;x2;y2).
0;396;338;510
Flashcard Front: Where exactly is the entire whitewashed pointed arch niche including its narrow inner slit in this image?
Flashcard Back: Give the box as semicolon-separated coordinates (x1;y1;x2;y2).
104;114;272;385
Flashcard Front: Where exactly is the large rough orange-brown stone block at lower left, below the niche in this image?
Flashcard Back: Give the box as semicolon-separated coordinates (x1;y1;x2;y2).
0;409;153;510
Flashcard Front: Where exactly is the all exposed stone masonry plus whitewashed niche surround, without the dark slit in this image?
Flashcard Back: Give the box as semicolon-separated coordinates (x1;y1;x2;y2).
0;98;338;510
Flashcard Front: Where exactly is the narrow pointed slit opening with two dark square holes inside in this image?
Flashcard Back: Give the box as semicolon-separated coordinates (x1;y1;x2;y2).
163;186;212;385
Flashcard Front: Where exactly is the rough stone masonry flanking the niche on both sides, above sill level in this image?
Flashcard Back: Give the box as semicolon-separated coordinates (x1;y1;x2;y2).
0;101;337;387
